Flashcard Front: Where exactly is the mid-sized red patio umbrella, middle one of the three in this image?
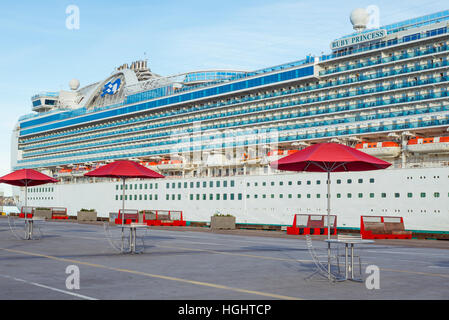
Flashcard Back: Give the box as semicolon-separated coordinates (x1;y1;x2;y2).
84;160;165;225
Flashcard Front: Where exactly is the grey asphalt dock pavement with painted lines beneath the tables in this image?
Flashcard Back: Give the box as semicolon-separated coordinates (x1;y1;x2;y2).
0;217;449;300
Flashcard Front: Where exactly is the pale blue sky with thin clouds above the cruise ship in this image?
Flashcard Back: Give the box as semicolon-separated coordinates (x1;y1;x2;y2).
0;0;449;195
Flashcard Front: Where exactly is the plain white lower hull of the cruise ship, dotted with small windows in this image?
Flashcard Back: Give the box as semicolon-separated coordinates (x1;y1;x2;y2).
17;168;449;232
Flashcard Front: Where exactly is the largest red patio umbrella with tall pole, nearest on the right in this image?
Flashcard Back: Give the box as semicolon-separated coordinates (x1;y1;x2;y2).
270;143;391;276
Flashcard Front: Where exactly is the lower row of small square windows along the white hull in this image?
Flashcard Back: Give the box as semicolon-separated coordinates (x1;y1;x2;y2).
115;192;442;200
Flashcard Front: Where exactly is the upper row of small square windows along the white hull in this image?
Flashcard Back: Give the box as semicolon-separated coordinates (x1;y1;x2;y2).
115;178;374;190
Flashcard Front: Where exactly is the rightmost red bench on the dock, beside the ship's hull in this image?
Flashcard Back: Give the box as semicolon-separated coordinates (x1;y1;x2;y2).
360;216;412;239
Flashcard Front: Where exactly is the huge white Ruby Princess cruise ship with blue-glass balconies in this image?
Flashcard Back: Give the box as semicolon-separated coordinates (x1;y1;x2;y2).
11;9;449;233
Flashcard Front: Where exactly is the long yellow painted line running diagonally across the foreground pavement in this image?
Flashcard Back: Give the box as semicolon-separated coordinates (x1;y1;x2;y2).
0;248;303;300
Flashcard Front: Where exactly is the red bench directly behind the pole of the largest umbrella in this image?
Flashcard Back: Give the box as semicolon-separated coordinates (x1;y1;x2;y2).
287;214;337;235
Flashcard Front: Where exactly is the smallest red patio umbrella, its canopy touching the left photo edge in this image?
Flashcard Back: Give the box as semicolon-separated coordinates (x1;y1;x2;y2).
0;169;58;211
